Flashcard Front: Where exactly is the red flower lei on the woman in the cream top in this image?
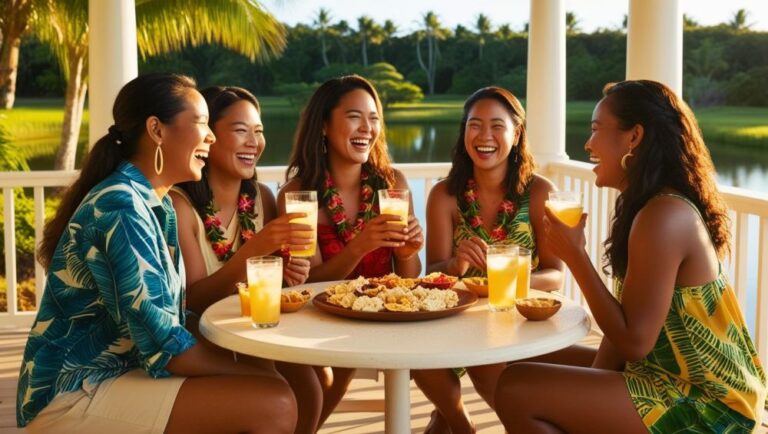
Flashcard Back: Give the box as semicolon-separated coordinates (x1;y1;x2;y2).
203;193;256;262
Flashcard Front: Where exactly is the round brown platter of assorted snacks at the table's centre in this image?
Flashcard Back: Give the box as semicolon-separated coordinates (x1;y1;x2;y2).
312;274;477;321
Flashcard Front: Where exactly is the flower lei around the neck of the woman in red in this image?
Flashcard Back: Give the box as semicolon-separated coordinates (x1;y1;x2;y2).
323;168;378;244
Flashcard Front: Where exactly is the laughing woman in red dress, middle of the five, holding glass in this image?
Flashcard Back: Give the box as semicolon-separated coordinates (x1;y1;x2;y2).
278;75;423;428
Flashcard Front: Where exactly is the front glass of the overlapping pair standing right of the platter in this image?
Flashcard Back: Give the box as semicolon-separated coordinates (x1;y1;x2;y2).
486;243;519;312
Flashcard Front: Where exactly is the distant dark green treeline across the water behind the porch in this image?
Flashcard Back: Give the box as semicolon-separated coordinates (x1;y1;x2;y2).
18;21;768;106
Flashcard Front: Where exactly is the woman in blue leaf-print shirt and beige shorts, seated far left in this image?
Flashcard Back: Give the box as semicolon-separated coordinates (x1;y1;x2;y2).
16;74;296;433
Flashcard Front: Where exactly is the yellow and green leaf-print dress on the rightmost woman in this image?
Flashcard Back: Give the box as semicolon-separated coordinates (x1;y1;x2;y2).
615;271;766;433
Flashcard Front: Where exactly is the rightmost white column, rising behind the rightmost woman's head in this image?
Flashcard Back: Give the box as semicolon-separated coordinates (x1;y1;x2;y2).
627;0;683;95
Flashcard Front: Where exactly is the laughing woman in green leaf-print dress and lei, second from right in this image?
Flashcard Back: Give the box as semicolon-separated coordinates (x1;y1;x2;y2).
413;87;564;434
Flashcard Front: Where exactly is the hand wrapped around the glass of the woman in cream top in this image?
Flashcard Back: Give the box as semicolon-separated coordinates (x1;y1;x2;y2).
246;212;315;255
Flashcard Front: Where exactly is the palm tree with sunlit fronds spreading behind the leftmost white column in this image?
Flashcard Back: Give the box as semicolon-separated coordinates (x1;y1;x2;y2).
35;0;285;170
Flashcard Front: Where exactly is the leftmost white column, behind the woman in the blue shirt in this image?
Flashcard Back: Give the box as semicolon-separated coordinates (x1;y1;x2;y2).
88;0;139;145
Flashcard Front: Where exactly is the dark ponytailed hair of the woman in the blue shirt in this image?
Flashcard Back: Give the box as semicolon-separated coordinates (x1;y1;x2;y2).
38;73;195;268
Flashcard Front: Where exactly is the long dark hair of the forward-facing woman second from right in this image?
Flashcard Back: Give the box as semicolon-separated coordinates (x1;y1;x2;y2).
447;86;535;201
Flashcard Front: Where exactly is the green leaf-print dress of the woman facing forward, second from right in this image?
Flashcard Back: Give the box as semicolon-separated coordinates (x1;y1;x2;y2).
453;182;539;277
